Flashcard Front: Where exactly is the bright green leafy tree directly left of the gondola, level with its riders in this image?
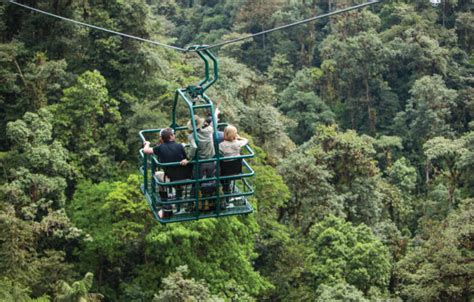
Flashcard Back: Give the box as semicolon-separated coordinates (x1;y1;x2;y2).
53;71;125;180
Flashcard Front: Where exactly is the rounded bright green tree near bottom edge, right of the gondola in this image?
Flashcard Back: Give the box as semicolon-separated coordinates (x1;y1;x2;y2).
307;216;390;294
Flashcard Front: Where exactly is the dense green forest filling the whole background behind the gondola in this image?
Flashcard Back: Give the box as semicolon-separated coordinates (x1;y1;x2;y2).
0;0;474;302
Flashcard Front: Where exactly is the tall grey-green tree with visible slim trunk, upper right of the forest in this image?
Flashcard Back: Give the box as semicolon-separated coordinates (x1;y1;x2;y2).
321;31;397;135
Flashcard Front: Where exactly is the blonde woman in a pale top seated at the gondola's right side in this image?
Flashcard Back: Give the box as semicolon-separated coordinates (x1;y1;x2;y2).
219;125;249;194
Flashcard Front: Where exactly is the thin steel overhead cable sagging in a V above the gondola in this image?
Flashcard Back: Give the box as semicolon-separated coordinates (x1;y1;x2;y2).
9;0;384;52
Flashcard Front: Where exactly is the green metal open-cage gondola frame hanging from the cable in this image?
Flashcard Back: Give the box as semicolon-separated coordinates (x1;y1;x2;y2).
139;46;255;223
